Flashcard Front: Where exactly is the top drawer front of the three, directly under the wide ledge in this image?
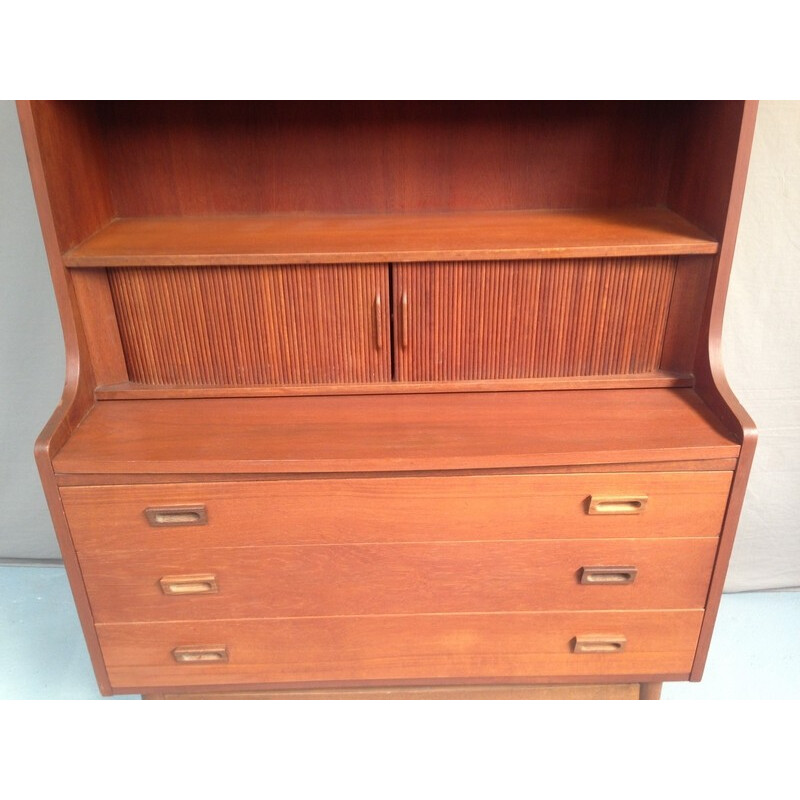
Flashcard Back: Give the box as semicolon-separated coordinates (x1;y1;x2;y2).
61;472;732;553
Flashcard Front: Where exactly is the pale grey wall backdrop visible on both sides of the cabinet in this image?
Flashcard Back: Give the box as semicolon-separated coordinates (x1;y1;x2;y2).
0;101;800;591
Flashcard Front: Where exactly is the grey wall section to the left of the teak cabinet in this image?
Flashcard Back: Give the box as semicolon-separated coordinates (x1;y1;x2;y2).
0;100;64;558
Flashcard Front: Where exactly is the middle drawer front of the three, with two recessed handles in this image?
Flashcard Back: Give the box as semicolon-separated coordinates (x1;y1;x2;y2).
80;538;717;622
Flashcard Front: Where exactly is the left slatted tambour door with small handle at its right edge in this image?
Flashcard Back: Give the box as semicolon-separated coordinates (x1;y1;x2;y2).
109;264;391;386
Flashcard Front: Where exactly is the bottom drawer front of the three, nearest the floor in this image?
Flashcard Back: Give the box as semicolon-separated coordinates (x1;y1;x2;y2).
97;610;703;691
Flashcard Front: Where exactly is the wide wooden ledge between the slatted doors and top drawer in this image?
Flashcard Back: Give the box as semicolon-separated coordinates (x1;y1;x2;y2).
54;389;739;475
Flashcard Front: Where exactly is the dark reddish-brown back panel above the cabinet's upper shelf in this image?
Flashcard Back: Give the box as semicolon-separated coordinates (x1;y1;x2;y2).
96;101;691;217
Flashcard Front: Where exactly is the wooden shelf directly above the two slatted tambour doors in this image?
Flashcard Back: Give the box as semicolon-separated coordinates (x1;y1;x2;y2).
64;208;718;267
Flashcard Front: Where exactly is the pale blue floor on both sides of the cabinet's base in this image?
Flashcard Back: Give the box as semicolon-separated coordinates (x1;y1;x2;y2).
0;566;800;700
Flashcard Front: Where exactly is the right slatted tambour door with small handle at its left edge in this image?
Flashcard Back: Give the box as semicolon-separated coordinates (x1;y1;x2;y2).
393;257;676;381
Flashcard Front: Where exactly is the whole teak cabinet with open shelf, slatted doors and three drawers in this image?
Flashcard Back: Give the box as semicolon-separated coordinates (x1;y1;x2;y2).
19;101;756;697
